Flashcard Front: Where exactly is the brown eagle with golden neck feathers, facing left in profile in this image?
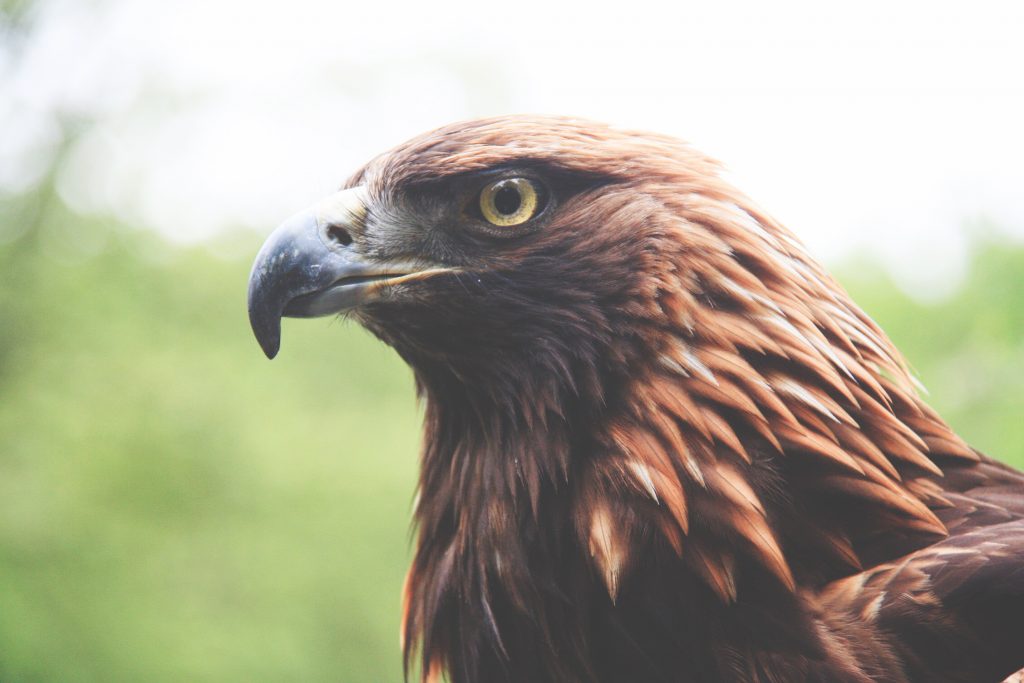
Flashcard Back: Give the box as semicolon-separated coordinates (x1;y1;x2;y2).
248;116;1024;683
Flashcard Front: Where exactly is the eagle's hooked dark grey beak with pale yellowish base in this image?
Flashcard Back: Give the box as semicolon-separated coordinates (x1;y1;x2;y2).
249;186;443;358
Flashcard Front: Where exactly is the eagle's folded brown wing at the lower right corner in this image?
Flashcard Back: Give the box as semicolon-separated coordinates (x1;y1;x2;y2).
811;520;1024;683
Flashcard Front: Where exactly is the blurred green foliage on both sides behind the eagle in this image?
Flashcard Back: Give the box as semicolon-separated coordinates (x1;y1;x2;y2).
0;188;1024;683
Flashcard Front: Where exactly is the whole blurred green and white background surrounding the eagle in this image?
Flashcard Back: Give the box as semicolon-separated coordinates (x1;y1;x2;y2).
0;0;1024;682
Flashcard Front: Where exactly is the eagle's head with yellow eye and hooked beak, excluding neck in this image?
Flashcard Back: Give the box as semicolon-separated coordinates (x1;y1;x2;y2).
249;117;737;409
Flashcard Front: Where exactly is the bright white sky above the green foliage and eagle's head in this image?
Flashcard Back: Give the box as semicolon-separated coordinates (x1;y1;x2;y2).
0;0;1024;297
